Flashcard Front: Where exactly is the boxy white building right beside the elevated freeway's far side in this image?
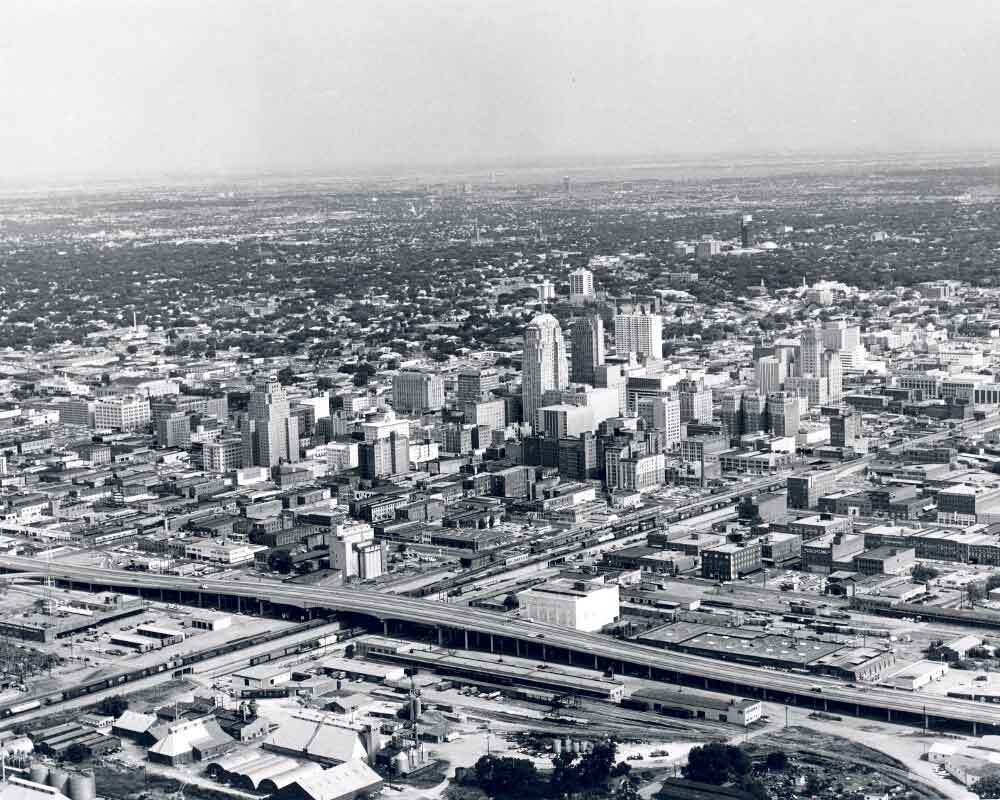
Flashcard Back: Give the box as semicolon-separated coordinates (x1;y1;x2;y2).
518;578;619;632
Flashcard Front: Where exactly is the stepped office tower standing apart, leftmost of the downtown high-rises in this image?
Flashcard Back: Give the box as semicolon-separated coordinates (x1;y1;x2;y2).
243;375;299;467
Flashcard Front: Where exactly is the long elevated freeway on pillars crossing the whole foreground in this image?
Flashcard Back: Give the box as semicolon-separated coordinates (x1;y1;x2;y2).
0;556;1000;733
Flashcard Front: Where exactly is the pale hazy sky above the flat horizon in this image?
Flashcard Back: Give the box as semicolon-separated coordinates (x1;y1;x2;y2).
0;0;1000;178
